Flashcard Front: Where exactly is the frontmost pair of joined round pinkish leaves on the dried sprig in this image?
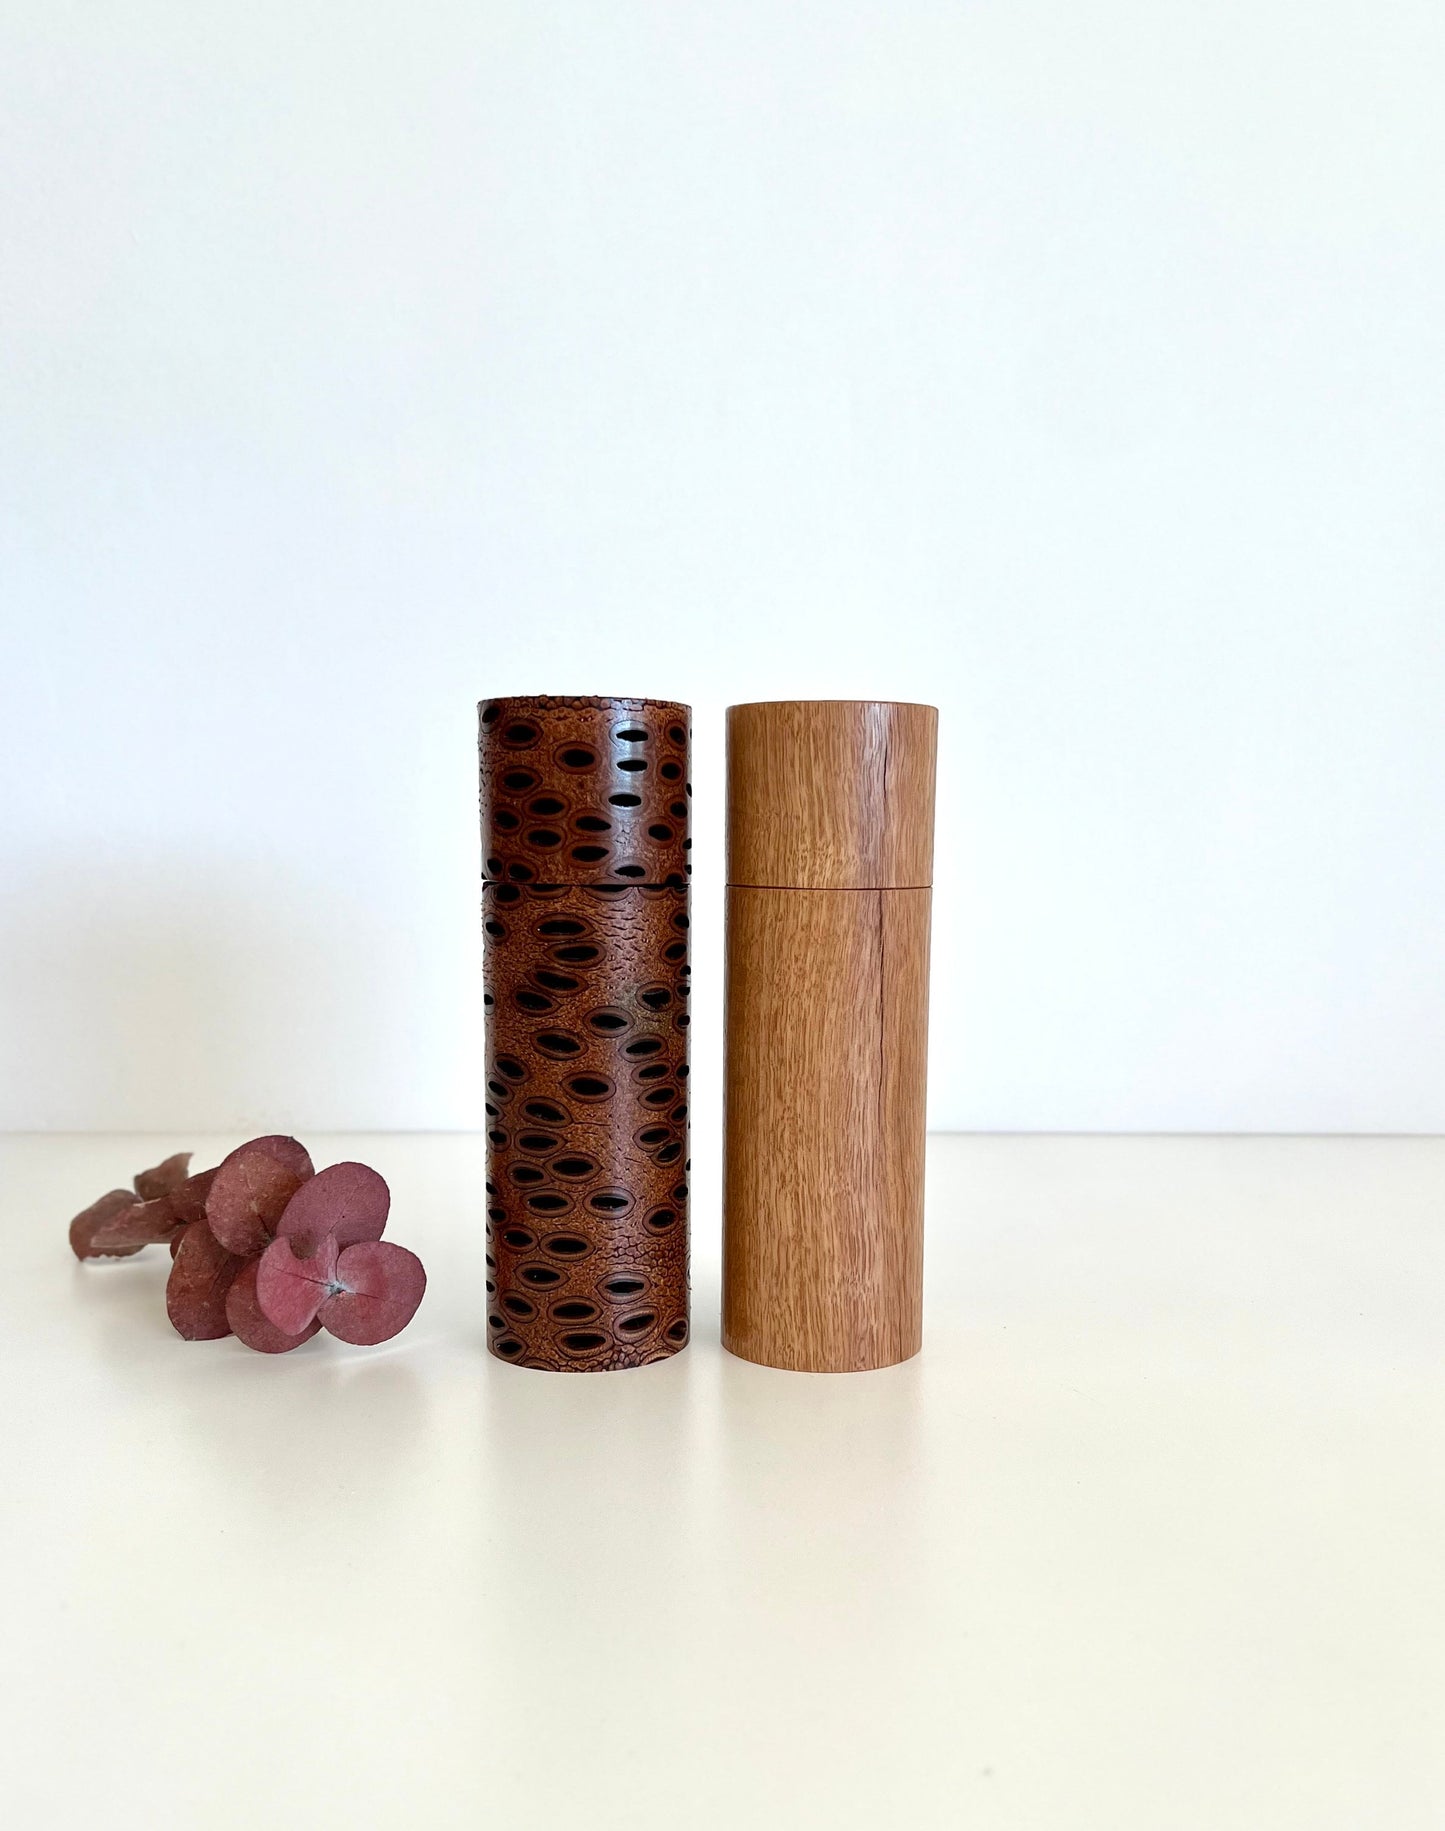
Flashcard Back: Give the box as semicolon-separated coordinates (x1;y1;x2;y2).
256;1234;427;1346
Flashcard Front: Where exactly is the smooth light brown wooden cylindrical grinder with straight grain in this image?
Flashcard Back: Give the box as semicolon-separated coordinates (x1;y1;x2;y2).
723;699;938;1373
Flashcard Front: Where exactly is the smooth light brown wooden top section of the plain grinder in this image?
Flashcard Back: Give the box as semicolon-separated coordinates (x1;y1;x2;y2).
727;699;938;890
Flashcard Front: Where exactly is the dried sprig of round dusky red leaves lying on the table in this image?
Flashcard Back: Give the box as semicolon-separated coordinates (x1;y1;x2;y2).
70;1135;427;1355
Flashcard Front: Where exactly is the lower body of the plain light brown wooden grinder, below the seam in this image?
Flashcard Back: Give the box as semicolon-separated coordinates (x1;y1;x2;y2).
723;888;932;1373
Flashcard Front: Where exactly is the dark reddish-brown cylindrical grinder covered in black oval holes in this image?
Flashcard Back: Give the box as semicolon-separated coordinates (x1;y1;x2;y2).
480;696;692;1371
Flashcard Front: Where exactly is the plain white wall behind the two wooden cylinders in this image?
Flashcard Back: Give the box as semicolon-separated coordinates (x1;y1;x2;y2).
0;0;1445;1127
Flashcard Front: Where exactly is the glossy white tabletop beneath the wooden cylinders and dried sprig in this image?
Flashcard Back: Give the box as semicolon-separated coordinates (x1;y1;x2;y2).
0;1137;1445;1831
